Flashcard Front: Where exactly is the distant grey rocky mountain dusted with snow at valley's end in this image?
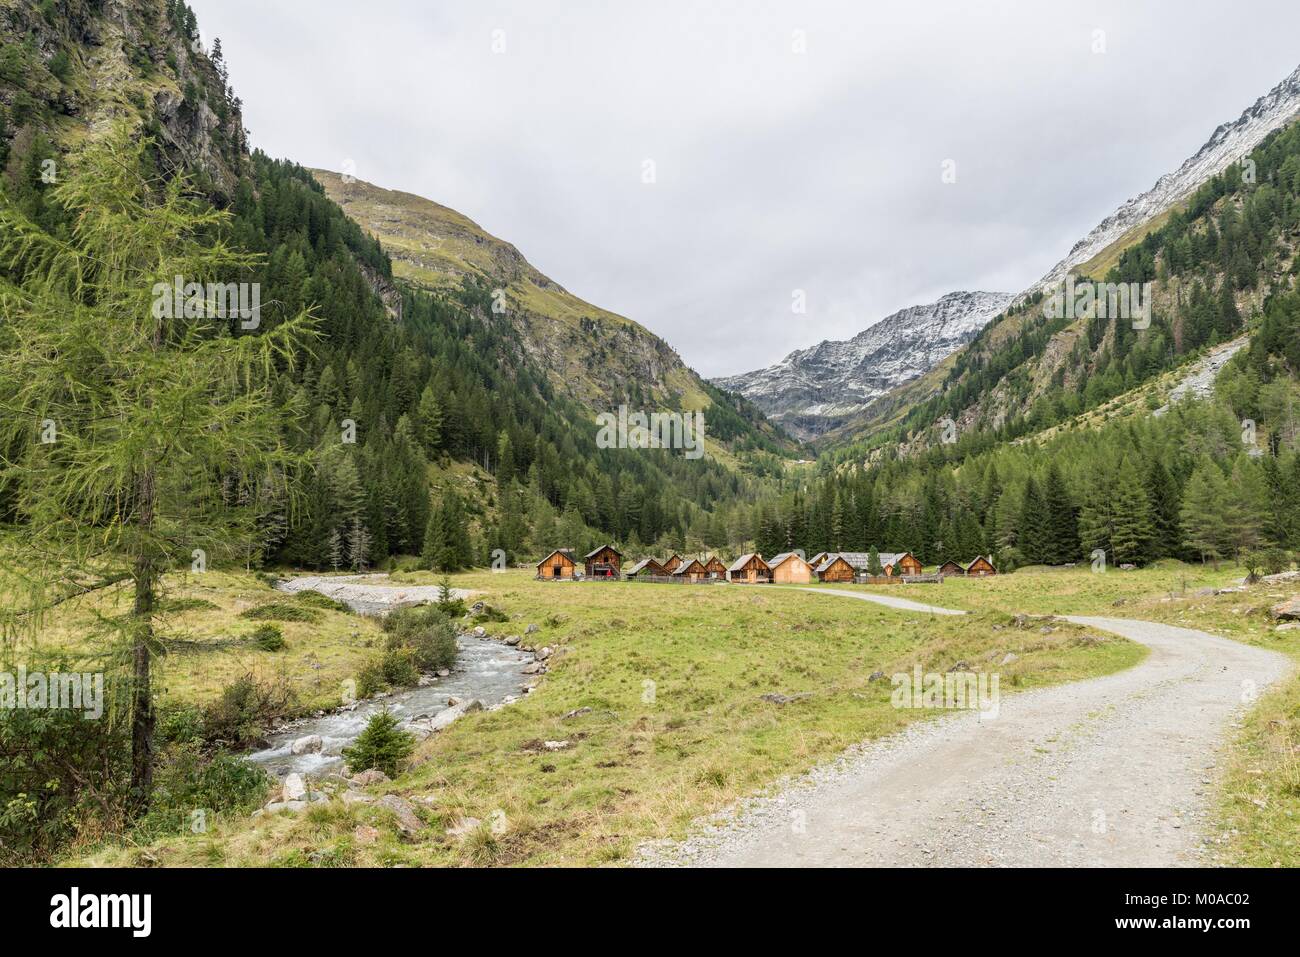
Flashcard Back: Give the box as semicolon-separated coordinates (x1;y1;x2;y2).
714;293;1011;439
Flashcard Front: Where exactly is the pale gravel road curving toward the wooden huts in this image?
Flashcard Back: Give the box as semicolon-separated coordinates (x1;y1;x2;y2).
645;589;1290;867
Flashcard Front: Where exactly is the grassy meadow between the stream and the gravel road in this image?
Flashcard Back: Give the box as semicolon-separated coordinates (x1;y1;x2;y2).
73;572;1143;865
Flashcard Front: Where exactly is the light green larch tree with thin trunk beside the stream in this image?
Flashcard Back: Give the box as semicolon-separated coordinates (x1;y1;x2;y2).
0;126;312;811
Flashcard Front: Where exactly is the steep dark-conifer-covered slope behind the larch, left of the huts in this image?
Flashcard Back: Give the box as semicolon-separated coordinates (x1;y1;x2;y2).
0;0;784;570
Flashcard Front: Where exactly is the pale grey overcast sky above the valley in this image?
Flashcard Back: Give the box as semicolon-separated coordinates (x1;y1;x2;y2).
190;0;1300;376
